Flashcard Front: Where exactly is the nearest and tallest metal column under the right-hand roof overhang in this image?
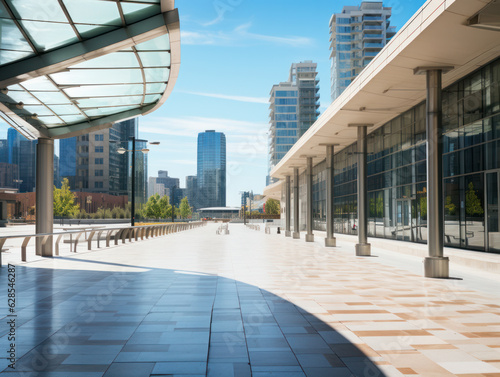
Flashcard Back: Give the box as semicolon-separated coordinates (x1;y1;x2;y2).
415;67;452;278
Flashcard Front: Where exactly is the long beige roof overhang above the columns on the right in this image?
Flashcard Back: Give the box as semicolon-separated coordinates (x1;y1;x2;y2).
272;0;500;181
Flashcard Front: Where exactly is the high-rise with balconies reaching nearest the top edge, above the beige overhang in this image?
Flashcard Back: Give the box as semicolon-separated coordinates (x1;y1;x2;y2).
330;1;396;101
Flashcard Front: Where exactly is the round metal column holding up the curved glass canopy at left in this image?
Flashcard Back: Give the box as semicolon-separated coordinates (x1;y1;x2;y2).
35;139;54;257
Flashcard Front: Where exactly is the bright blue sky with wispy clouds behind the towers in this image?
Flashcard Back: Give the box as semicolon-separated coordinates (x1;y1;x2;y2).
0;0;424;206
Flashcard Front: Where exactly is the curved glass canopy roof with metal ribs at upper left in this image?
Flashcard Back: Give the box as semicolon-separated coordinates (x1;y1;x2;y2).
0;0;180;139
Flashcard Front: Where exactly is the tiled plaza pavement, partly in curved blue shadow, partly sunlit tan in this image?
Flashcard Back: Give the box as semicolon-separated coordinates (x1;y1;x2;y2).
0;225;500;377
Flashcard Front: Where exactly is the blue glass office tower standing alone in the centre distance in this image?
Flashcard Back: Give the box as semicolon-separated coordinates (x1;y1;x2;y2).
197;130;226;208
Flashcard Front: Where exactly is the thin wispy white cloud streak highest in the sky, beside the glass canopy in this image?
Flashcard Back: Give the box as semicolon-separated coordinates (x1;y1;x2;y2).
181;23;314;47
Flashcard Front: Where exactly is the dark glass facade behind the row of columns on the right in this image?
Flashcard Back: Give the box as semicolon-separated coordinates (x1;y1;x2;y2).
308;60;500;252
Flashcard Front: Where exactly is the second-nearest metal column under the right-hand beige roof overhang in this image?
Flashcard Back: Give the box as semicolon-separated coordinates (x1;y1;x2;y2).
354;124;371;257
